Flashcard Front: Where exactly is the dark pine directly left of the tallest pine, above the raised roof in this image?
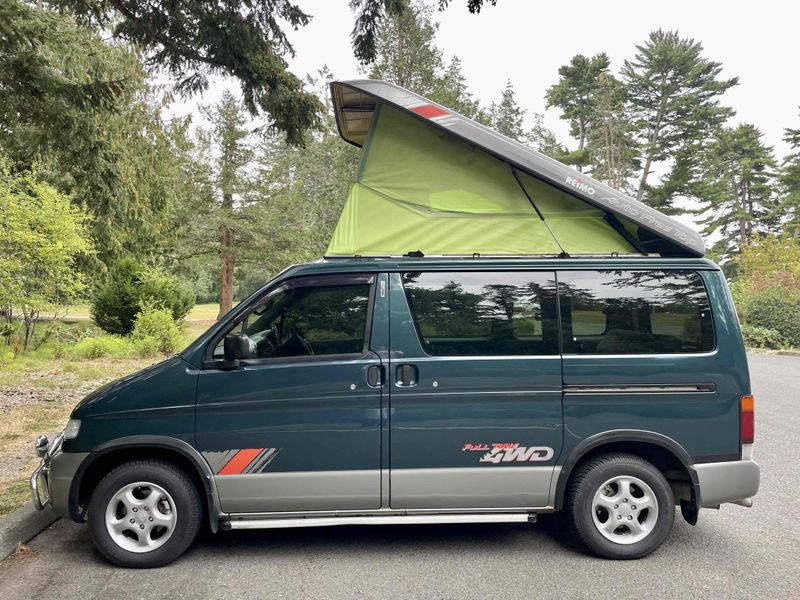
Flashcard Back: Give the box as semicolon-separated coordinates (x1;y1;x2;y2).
545;52;611;171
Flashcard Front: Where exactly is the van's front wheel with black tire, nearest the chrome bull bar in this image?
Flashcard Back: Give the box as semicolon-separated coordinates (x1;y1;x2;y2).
88;460;203;569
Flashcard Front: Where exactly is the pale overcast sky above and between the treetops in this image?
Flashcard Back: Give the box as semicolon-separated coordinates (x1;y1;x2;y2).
274;0;800;156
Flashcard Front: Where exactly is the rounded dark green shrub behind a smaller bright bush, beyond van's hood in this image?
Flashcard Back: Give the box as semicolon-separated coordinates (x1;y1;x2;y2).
92;259;194;335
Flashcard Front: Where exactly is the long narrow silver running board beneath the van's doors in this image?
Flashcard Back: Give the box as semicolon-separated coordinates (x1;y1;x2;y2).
221;513;536;530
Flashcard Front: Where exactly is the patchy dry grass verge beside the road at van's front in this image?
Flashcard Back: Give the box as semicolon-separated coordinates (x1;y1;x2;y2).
0;304;225;516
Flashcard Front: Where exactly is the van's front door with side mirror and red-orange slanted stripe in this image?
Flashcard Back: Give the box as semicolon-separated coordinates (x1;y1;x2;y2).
196;275;381;513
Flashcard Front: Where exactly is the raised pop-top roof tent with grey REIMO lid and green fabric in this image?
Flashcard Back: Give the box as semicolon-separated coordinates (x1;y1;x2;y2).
326;80;705;257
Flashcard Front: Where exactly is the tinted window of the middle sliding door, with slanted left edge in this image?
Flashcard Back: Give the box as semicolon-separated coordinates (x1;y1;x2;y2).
403;272;558;356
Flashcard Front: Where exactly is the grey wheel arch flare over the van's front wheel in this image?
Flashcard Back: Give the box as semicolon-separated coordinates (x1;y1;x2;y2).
69;436;224;532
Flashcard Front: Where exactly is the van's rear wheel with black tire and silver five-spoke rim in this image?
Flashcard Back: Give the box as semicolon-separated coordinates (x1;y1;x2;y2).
566;453;675;560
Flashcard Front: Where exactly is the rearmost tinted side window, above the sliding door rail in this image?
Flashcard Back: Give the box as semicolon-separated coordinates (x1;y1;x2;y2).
558;271;714;354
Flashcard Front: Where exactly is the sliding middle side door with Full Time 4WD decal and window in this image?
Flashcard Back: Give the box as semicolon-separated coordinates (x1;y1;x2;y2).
389;271;563;509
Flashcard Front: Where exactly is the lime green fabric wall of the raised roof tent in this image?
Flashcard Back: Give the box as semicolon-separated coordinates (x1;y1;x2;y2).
326;104;635;257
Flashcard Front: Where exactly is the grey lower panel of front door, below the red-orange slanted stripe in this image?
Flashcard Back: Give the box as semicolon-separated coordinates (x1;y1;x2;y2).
214;469;381;513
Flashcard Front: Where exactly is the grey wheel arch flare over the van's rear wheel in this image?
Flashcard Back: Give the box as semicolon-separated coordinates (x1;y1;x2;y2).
553;429;700;512
